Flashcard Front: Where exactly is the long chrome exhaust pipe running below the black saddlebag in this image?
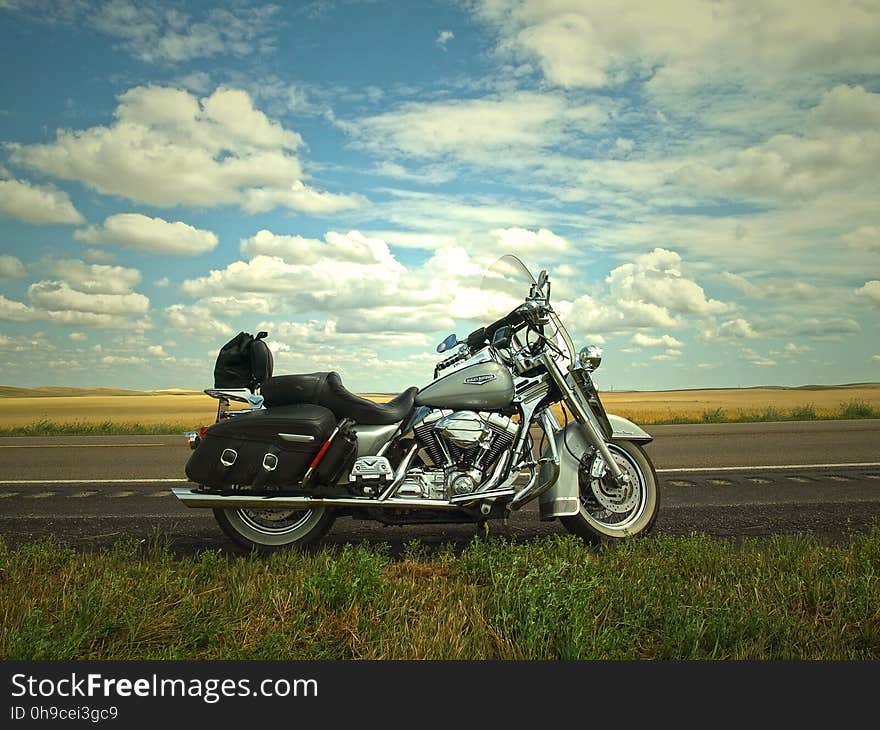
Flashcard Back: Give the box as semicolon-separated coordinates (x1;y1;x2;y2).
171;487;461;509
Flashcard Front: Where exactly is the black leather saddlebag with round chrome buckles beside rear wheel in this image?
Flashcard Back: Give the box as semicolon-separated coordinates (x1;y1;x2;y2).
186;404;336;488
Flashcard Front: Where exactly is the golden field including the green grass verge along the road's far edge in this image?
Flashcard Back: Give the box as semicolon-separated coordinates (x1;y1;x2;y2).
0;383;880;436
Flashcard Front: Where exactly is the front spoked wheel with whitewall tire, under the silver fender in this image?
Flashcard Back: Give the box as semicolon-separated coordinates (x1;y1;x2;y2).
559;441;660;543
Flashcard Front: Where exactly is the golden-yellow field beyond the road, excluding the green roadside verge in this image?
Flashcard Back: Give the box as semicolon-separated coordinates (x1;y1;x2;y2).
0;383;880;429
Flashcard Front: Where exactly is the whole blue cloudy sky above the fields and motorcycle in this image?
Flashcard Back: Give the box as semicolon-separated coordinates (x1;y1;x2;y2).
0;0;880;392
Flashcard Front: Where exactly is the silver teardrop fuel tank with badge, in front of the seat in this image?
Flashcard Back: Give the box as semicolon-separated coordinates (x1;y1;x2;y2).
416;362;513;411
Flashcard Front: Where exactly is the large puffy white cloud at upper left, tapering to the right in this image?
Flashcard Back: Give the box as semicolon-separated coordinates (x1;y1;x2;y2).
9;86;361;213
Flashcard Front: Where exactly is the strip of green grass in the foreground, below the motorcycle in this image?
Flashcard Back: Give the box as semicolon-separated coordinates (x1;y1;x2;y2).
0;526;880;660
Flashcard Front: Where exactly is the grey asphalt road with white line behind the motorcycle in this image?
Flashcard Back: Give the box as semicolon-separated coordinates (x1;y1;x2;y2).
0;420;880;551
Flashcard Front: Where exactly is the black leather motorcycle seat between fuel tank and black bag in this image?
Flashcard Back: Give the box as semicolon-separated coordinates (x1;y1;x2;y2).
260;372;419;426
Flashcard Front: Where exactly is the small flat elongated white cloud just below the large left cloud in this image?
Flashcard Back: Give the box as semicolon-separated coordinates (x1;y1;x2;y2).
73;213;217;255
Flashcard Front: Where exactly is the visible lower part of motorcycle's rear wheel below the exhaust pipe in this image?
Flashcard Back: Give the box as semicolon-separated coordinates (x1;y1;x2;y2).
214;507;336;552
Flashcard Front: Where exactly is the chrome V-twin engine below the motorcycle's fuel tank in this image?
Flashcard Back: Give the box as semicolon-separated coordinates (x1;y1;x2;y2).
398;410;519;499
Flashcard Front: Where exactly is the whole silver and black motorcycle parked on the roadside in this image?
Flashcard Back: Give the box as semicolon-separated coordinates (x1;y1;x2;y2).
173;255;660;551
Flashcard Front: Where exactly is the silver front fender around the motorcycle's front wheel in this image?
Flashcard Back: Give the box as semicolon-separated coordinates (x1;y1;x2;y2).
538;413;654;520
